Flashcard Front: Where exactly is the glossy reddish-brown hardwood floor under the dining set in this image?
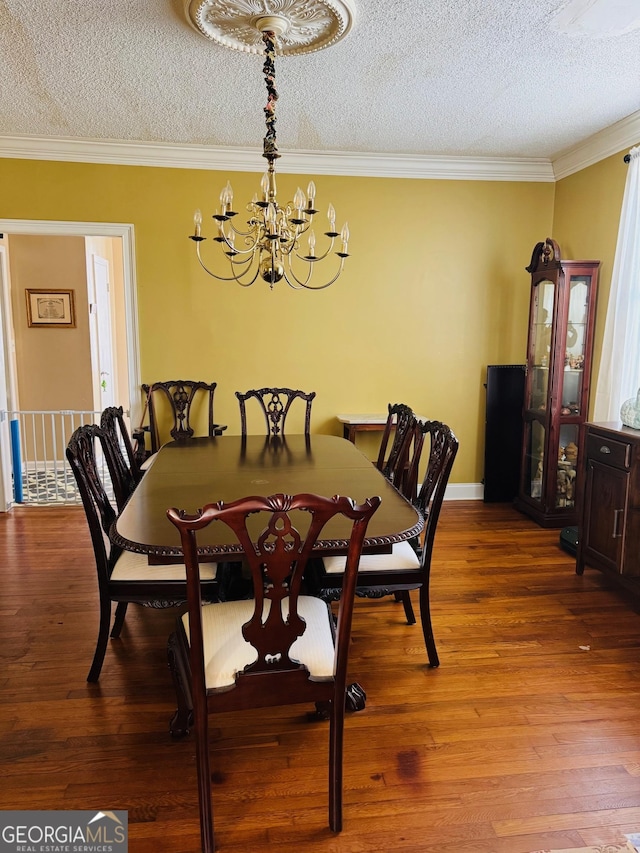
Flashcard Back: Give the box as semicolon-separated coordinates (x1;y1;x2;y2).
0;502;640;853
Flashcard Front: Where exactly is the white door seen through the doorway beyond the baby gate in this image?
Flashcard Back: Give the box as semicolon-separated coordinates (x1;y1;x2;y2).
89;254;117;412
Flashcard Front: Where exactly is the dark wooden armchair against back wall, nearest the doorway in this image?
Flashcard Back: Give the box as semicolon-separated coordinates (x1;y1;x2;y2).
141;379;227;453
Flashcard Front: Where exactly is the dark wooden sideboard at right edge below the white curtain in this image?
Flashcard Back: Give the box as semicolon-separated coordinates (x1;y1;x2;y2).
576;422;640;591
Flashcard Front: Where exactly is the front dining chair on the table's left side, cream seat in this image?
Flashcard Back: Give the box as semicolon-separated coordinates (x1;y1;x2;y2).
66;424;218;681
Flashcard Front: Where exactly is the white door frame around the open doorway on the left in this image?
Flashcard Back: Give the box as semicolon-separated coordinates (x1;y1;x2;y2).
0;219;142;511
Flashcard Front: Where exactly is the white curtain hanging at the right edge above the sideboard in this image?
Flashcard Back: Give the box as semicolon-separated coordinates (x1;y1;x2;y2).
594;145;640;421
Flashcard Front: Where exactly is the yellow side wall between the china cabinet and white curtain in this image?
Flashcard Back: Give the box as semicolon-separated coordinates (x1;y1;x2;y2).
552;153;628;413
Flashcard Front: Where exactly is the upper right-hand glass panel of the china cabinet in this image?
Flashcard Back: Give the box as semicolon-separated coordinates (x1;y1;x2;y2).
560;275;591;416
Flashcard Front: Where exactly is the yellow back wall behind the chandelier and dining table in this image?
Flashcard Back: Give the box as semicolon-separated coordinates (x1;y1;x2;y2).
0;160;555;483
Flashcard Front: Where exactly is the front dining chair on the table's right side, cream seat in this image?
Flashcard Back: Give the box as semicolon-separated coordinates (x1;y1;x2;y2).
309;421;458;667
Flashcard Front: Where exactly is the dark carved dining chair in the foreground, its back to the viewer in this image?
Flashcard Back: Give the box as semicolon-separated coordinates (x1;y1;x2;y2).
167;494;381;853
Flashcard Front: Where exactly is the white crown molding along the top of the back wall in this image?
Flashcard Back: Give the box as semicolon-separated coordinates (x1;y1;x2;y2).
0;136;555;183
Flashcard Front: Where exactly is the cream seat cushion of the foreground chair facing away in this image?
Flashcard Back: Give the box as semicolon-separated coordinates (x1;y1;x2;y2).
182;595;335;690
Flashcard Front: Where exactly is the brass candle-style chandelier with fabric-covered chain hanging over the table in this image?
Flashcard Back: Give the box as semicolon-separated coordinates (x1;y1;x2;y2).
189;0;349;290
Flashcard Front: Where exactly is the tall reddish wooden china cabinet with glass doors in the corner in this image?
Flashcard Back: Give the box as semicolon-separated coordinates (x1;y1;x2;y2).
516;237;600;527
